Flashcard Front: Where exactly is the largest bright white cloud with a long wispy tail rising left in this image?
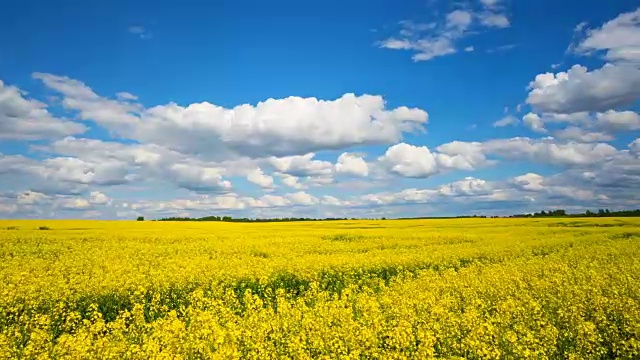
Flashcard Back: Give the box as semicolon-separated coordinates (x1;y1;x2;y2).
33;73;428;159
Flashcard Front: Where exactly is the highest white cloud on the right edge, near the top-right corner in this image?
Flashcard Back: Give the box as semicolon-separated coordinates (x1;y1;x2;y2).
572;8;640;63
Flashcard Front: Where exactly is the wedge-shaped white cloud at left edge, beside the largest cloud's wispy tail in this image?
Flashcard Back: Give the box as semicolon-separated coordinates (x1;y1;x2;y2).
0;80;87;140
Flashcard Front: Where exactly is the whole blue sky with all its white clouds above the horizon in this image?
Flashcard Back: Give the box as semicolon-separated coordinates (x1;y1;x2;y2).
0;0;640;218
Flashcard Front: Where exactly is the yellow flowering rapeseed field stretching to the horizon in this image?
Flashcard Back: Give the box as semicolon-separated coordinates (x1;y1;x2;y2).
0;218;640;359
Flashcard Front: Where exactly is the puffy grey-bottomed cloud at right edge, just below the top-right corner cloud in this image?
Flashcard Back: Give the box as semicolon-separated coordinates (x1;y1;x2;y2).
527;64;640;114
